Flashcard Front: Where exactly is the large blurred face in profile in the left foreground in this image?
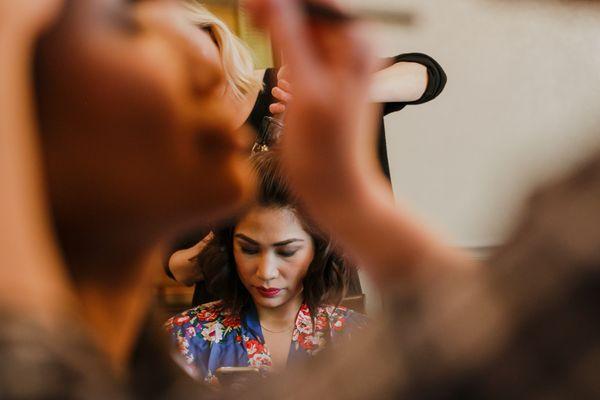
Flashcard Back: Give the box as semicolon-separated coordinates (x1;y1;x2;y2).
37;0;253;242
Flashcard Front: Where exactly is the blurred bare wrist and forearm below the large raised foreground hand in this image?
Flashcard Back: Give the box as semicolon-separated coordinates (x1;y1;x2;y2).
295;162;474;284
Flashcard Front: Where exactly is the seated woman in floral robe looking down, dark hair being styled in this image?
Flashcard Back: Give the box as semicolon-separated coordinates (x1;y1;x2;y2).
166;152;367;382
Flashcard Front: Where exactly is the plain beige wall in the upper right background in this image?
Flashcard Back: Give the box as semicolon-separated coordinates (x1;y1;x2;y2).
350;0;600;247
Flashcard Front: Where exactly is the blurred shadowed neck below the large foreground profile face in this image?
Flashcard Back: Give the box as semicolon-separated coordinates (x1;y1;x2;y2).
72;247;156;376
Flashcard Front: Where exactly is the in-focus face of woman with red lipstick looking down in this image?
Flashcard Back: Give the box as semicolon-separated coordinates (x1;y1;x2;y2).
233;207;314;308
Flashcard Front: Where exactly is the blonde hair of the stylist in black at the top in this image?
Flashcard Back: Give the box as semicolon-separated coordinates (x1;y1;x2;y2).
180;0;263;99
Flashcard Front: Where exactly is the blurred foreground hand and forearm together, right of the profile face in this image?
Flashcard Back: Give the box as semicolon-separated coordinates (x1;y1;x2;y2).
250;0;472;284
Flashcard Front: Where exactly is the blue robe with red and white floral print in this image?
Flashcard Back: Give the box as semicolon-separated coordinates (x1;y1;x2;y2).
166;301;367;383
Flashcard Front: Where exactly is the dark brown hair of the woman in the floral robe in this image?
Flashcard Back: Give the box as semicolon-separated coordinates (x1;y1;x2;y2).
197;151;351;316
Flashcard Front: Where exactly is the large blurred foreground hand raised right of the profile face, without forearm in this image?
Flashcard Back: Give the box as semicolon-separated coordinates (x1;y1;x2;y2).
247;0;376;194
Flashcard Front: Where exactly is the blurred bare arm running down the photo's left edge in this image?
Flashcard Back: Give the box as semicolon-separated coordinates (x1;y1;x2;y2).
0;1;77;327
